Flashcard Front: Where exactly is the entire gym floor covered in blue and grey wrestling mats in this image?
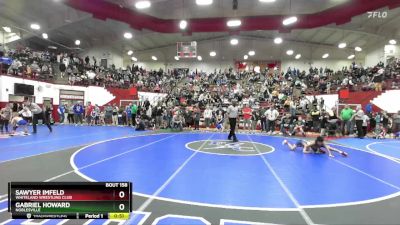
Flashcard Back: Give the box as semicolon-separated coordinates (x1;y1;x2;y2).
0;125;400;225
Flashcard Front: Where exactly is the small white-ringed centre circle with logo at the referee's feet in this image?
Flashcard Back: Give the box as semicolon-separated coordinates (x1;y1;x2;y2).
186;140;273;155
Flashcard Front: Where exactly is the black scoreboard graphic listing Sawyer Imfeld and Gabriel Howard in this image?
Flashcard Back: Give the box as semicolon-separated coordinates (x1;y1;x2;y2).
8;182;132;220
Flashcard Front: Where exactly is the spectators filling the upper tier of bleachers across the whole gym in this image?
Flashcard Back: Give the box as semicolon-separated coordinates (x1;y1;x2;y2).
0;48;400;94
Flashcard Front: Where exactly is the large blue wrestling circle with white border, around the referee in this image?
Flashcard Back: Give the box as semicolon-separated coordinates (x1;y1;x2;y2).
70;133;400;210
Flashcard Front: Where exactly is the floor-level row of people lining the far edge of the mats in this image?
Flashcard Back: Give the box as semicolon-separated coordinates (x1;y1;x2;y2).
23;93;400;138
